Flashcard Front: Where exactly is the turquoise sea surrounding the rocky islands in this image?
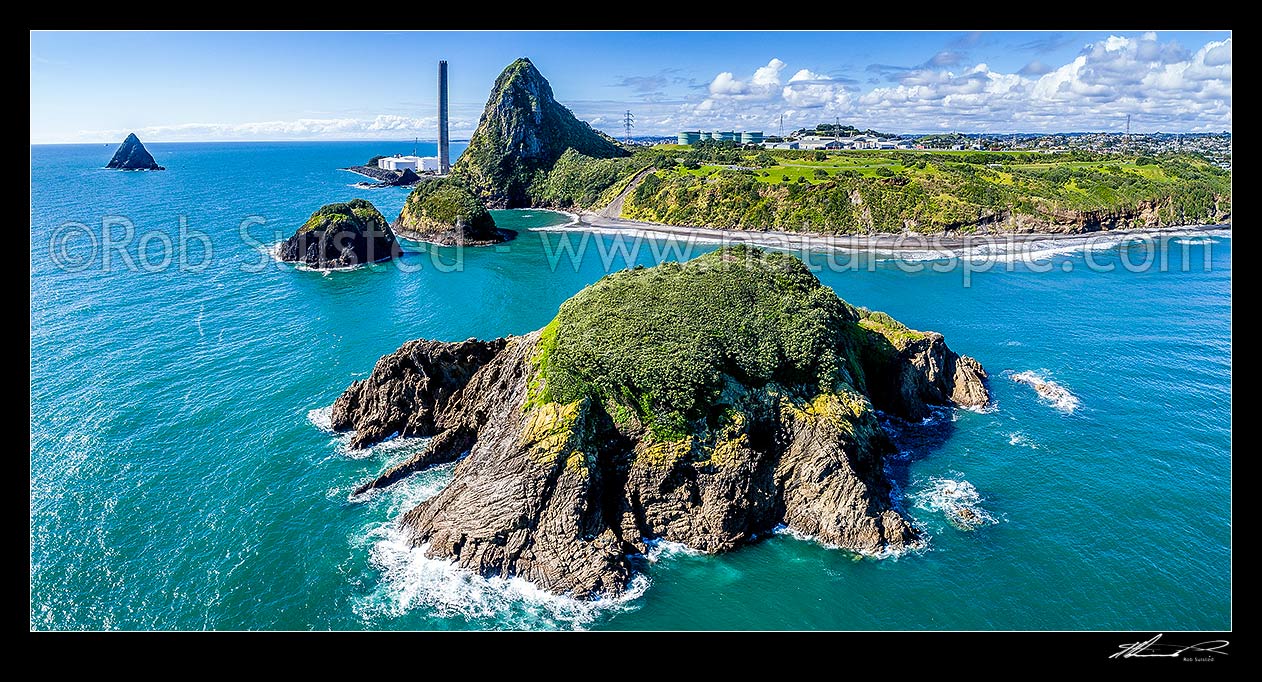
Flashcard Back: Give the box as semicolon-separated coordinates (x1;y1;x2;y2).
30;143;1232;630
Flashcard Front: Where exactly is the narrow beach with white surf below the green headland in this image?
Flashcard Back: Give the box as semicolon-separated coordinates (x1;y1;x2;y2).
547;211;1232;251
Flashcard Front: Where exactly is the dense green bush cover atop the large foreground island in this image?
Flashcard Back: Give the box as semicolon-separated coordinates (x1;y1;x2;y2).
530;246;938;441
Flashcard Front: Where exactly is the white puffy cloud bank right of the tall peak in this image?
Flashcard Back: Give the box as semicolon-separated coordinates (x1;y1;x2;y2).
676;33;1232;131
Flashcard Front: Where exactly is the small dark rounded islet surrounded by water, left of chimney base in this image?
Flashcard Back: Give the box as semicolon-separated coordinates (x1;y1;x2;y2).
278;200;401;269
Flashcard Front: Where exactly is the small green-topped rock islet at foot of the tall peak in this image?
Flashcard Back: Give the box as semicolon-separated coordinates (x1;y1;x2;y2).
394;178;517;246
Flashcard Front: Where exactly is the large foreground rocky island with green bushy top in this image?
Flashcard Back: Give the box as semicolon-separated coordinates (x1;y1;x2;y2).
333;248;988;599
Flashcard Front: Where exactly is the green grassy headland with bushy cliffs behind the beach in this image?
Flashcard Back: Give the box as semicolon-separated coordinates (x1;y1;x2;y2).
517;143;1232;234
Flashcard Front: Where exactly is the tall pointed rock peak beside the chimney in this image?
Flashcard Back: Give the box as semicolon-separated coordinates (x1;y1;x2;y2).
452;58;627;208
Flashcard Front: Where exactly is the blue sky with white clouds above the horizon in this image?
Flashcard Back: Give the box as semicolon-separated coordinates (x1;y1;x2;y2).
30;32;1232;144
